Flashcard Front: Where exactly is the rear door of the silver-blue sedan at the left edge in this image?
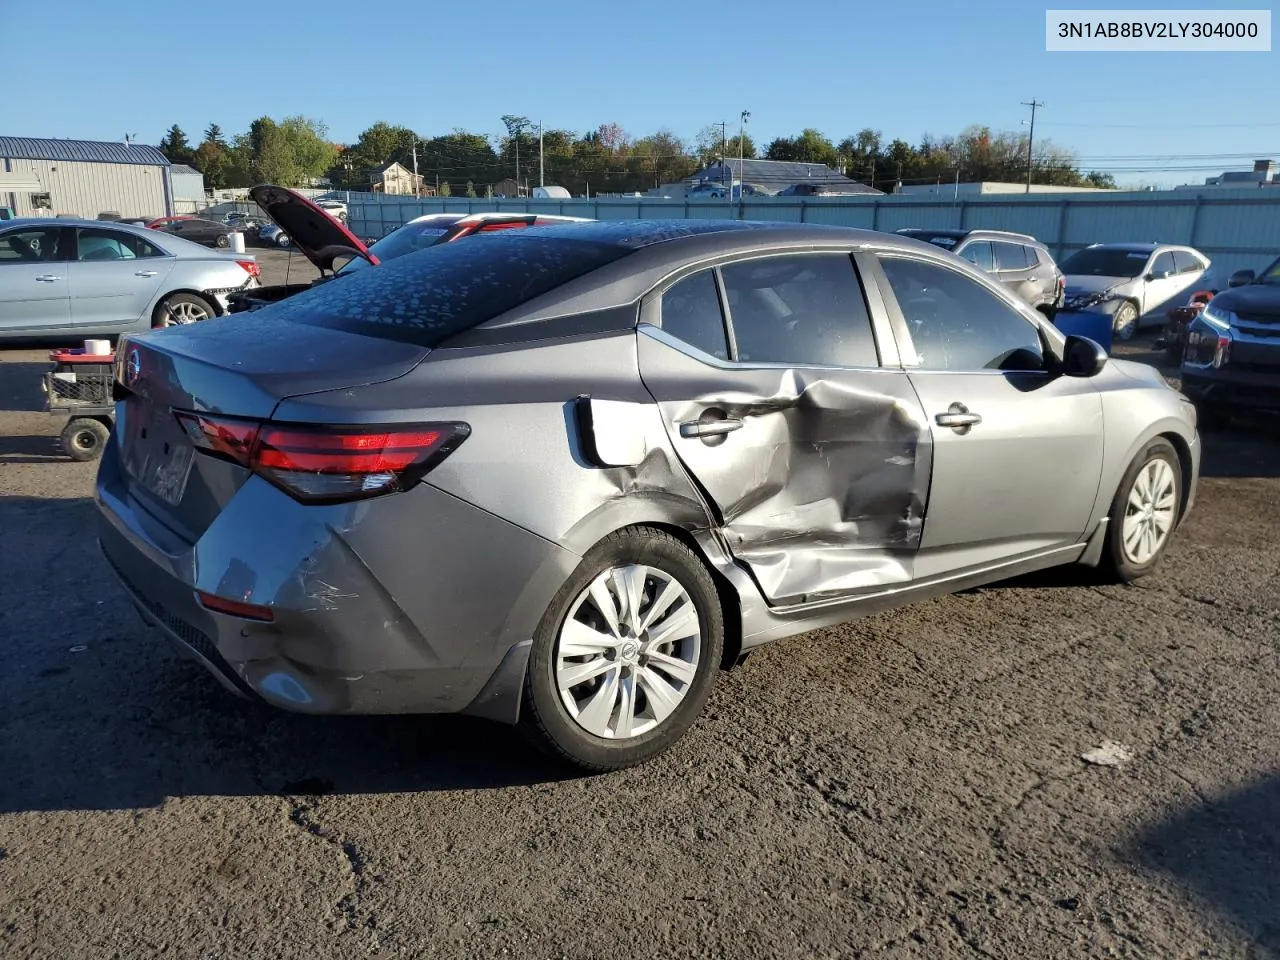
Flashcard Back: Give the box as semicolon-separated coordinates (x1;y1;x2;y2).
69;227;174;330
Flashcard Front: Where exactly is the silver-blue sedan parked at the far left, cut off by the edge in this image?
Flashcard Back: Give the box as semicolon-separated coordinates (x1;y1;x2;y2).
0;219;260;339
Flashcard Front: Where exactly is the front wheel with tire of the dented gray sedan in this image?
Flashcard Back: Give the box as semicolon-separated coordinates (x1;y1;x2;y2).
1102;438;1183;584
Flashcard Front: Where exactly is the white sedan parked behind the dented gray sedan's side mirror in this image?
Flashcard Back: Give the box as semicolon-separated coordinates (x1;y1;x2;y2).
1060;243;1212;340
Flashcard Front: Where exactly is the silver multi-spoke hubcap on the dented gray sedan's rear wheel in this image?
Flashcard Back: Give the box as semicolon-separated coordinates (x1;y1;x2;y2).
556;564;701;740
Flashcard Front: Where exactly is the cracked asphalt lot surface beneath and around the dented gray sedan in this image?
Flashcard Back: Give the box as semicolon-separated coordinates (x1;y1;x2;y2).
0;251;1280;960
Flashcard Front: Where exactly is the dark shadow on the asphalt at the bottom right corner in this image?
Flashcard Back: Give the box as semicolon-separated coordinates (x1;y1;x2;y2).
1120;776;1280;957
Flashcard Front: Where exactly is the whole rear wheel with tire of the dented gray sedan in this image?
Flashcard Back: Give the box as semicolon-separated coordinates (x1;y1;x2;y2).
521;527;724;772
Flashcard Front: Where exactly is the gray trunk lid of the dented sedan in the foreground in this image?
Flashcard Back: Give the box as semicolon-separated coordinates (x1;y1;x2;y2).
115;314;430;543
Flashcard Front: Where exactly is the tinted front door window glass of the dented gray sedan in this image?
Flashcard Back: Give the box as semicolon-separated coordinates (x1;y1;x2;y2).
881;256;1044;371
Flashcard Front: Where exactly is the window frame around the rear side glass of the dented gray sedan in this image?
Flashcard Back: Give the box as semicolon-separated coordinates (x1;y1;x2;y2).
640;243;902;370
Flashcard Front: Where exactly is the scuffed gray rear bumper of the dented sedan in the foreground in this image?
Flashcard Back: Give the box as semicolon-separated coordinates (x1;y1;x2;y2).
96;443;579;722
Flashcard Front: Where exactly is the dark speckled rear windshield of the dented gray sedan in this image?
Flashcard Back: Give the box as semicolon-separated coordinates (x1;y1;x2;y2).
273;230;630;347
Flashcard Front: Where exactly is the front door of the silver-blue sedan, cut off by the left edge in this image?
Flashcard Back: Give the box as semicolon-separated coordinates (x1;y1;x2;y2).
0;227;70;333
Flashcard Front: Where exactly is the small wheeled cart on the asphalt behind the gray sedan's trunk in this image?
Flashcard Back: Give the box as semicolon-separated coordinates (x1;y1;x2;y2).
44;349;115;461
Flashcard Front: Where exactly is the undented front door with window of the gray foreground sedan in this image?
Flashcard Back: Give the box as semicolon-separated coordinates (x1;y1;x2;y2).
879;255;1103;579
